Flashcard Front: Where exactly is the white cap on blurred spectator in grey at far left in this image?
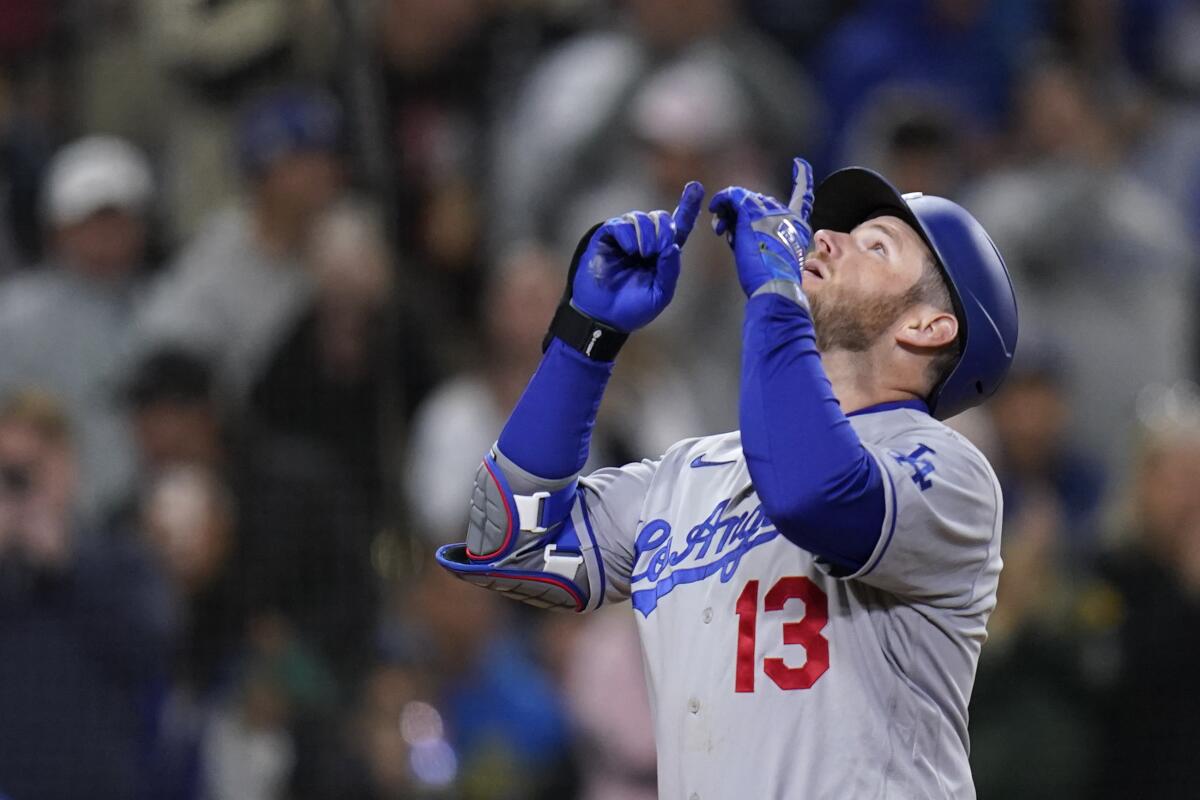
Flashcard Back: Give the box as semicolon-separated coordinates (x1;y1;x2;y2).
42;136;154;225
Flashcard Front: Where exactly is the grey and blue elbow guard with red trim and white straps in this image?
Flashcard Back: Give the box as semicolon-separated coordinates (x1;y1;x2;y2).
437;450;605;612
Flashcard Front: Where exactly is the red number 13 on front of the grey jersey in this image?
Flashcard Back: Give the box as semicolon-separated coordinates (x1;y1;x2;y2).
734;576;829;692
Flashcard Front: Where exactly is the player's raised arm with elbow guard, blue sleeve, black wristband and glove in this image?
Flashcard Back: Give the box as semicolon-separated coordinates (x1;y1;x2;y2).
437;190;704;610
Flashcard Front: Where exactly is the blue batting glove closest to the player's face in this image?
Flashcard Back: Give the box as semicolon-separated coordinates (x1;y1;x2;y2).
708;158;812;297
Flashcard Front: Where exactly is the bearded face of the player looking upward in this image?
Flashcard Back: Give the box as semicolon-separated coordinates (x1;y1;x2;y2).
804;216;932;351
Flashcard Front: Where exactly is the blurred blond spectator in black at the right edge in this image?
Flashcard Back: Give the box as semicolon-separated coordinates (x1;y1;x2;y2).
1091;385;1200;798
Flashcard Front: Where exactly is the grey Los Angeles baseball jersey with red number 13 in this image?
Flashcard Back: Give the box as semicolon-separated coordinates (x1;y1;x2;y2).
581;408;1002;800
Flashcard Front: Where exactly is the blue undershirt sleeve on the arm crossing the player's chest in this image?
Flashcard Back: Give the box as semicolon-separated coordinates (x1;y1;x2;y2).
739;294;884;573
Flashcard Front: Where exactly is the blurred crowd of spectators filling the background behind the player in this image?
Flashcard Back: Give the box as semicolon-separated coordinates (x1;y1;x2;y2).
0;0;1200;800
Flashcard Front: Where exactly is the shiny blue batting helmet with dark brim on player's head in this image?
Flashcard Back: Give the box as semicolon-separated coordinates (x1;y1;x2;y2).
810;167;1016;420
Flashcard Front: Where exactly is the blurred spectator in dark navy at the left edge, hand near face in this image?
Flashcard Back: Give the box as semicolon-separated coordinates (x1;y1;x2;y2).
0;391;172;800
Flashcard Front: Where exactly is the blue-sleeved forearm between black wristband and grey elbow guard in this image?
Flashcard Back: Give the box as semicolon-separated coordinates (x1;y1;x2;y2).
497;338;613;481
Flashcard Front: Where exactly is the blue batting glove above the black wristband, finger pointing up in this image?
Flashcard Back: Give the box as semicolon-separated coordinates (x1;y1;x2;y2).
571;181;704;333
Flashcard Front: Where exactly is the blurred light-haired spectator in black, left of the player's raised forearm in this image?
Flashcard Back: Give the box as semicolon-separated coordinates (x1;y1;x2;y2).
252;203;432;509
